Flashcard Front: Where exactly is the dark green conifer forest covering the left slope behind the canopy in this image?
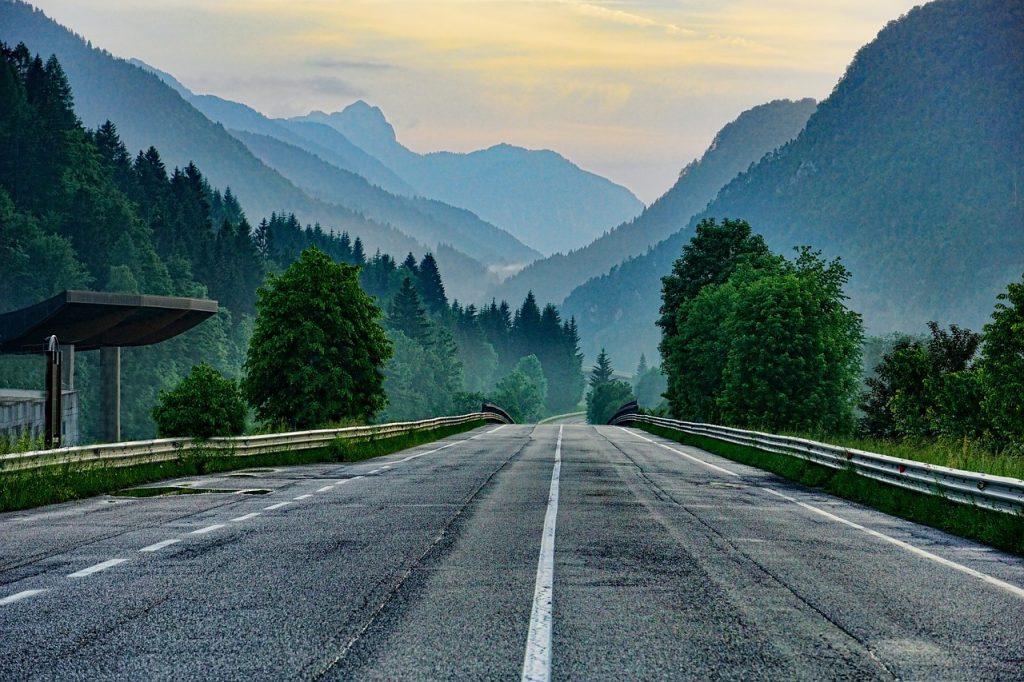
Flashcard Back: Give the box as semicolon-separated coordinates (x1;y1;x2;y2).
0;44;583;441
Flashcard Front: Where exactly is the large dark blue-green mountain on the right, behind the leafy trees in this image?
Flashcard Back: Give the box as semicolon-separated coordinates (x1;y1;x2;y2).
563;0;1024;365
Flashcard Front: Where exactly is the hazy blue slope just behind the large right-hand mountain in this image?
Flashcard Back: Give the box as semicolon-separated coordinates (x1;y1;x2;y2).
495;99;815;301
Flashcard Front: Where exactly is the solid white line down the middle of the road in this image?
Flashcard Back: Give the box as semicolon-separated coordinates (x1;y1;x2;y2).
522;426;562;682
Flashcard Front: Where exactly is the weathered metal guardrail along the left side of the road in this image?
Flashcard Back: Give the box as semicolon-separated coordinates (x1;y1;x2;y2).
0;412;495;472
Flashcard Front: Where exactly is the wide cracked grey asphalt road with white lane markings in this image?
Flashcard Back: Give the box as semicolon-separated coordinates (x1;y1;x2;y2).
0;425;1024;681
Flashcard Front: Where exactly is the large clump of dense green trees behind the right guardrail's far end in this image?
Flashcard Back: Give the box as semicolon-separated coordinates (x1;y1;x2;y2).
658;220;862;432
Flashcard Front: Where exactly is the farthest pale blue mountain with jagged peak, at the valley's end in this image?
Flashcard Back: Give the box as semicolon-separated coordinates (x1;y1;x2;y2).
299;101;643;254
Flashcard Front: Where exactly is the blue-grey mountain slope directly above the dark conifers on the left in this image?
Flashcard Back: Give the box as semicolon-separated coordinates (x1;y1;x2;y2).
0;0;423;258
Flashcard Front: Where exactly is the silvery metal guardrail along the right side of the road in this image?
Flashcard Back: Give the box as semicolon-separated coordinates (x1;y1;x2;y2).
609;414;1024;514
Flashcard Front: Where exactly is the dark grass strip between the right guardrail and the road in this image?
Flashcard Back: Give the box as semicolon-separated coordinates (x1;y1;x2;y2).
636;424;1024;556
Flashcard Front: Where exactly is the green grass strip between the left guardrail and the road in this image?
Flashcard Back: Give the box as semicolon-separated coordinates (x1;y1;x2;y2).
0;420;484;512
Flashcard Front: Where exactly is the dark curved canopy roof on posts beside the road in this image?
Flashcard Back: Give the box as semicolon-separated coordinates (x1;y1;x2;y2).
0;291;217;353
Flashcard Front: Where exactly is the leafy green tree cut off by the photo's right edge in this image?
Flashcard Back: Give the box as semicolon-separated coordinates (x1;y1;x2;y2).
980;280;1024;447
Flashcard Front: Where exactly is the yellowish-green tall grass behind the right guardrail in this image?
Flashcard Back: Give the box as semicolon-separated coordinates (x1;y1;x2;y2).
785;433;1024;479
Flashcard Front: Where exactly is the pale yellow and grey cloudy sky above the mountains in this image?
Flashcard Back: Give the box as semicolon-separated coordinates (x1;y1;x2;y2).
30;0;921;204
